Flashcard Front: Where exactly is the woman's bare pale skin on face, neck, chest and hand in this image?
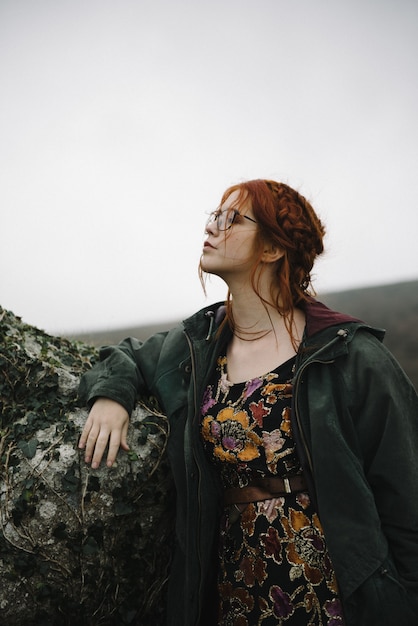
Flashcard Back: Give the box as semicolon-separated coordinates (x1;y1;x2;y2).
79;192;305;469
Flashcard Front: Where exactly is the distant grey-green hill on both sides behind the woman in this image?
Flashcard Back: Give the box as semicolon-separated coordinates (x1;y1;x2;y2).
72;280;418;389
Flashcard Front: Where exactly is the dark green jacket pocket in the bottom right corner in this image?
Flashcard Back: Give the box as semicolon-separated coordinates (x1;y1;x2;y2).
344;558;418;626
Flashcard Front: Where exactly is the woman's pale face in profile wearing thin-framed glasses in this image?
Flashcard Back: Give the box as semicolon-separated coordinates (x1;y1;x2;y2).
201;191;257;282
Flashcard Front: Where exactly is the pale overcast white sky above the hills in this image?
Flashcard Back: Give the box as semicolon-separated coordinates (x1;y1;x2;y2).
0;0;418;333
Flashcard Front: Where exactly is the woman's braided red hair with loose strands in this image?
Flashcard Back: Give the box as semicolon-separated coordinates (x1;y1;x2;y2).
201;180;325;338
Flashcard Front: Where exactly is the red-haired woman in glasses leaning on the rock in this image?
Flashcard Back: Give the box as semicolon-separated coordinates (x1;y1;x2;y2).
80;180;418;626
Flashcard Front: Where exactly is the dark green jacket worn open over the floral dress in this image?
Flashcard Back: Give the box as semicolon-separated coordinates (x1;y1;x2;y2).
80;300;418;626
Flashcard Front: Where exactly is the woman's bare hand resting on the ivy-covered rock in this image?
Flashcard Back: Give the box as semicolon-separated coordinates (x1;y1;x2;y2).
78;398;129;469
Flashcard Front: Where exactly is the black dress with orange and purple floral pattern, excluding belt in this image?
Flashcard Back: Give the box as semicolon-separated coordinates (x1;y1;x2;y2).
201;357;344;626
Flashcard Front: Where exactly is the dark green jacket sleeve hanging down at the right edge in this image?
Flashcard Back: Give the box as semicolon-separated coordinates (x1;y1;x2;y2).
351;333;418;594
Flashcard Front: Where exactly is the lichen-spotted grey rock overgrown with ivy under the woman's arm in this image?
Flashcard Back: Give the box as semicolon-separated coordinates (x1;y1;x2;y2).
0;308;173;626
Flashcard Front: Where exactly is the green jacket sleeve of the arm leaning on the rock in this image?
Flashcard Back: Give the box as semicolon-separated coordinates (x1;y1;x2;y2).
79;333;167;414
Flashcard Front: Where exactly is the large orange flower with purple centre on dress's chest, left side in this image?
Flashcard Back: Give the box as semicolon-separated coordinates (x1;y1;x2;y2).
202;407;261;463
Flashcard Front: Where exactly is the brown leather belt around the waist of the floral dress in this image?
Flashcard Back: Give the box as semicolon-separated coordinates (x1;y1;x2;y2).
224;474;307;506
